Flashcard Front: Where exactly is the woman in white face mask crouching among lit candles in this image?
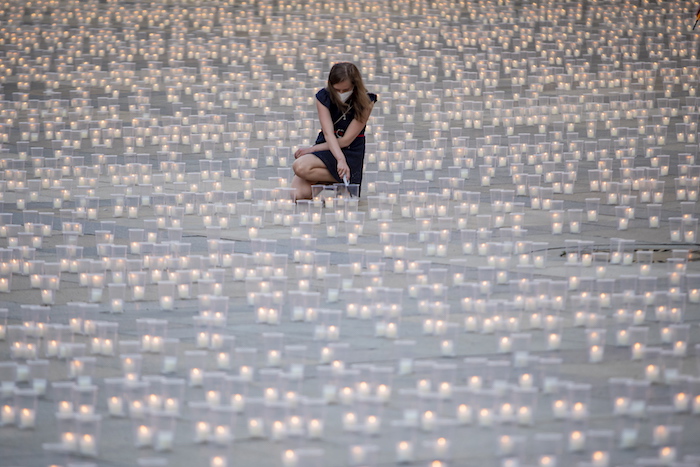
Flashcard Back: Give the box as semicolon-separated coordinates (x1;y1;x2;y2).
292;62;377;199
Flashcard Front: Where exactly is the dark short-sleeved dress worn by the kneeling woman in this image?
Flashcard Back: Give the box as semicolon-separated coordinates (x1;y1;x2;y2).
314;88;377;185
